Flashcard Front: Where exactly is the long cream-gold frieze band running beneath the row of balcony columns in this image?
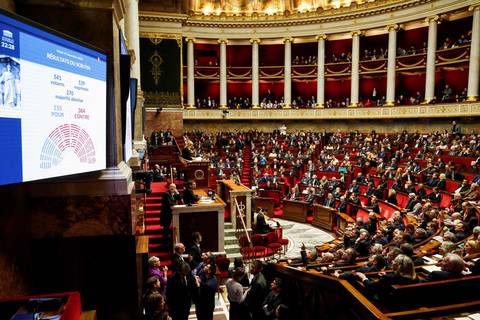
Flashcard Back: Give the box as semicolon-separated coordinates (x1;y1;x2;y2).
182;102;480;121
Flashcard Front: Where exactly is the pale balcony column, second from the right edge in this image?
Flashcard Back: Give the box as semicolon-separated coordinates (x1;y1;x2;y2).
425;15;439;103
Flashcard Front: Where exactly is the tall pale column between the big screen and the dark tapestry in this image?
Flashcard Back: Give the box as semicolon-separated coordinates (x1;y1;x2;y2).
124;0;146;149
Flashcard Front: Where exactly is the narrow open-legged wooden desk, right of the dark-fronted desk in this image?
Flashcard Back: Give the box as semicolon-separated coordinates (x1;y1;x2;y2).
217;180;252;231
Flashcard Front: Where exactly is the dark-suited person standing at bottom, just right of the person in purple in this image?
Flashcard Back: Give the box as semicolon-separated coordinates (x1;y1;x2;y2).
167;262;198;320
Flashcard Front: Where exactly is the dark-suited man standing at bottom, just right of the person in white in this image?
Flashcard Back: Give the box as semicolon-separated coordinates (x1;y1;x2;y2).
244;260;267;320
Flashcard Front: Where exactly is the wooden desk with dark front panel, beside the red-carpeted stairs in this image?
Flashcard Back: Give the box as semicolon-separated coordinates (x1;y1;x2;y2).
172;189;225;253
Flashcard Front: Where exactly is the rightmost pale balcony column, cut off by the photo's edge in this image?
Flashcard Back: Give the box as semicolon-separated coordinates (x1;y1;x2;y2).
467;4;480;101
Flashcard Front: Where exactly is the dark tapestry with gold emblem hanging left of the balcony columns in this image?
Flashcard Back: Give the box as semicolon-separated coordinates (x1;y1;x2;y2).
140;38;181;108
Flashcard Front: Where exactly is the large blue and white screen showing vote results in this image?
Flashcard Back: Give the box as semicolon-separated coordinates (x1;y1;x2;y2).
0;11;107;185
